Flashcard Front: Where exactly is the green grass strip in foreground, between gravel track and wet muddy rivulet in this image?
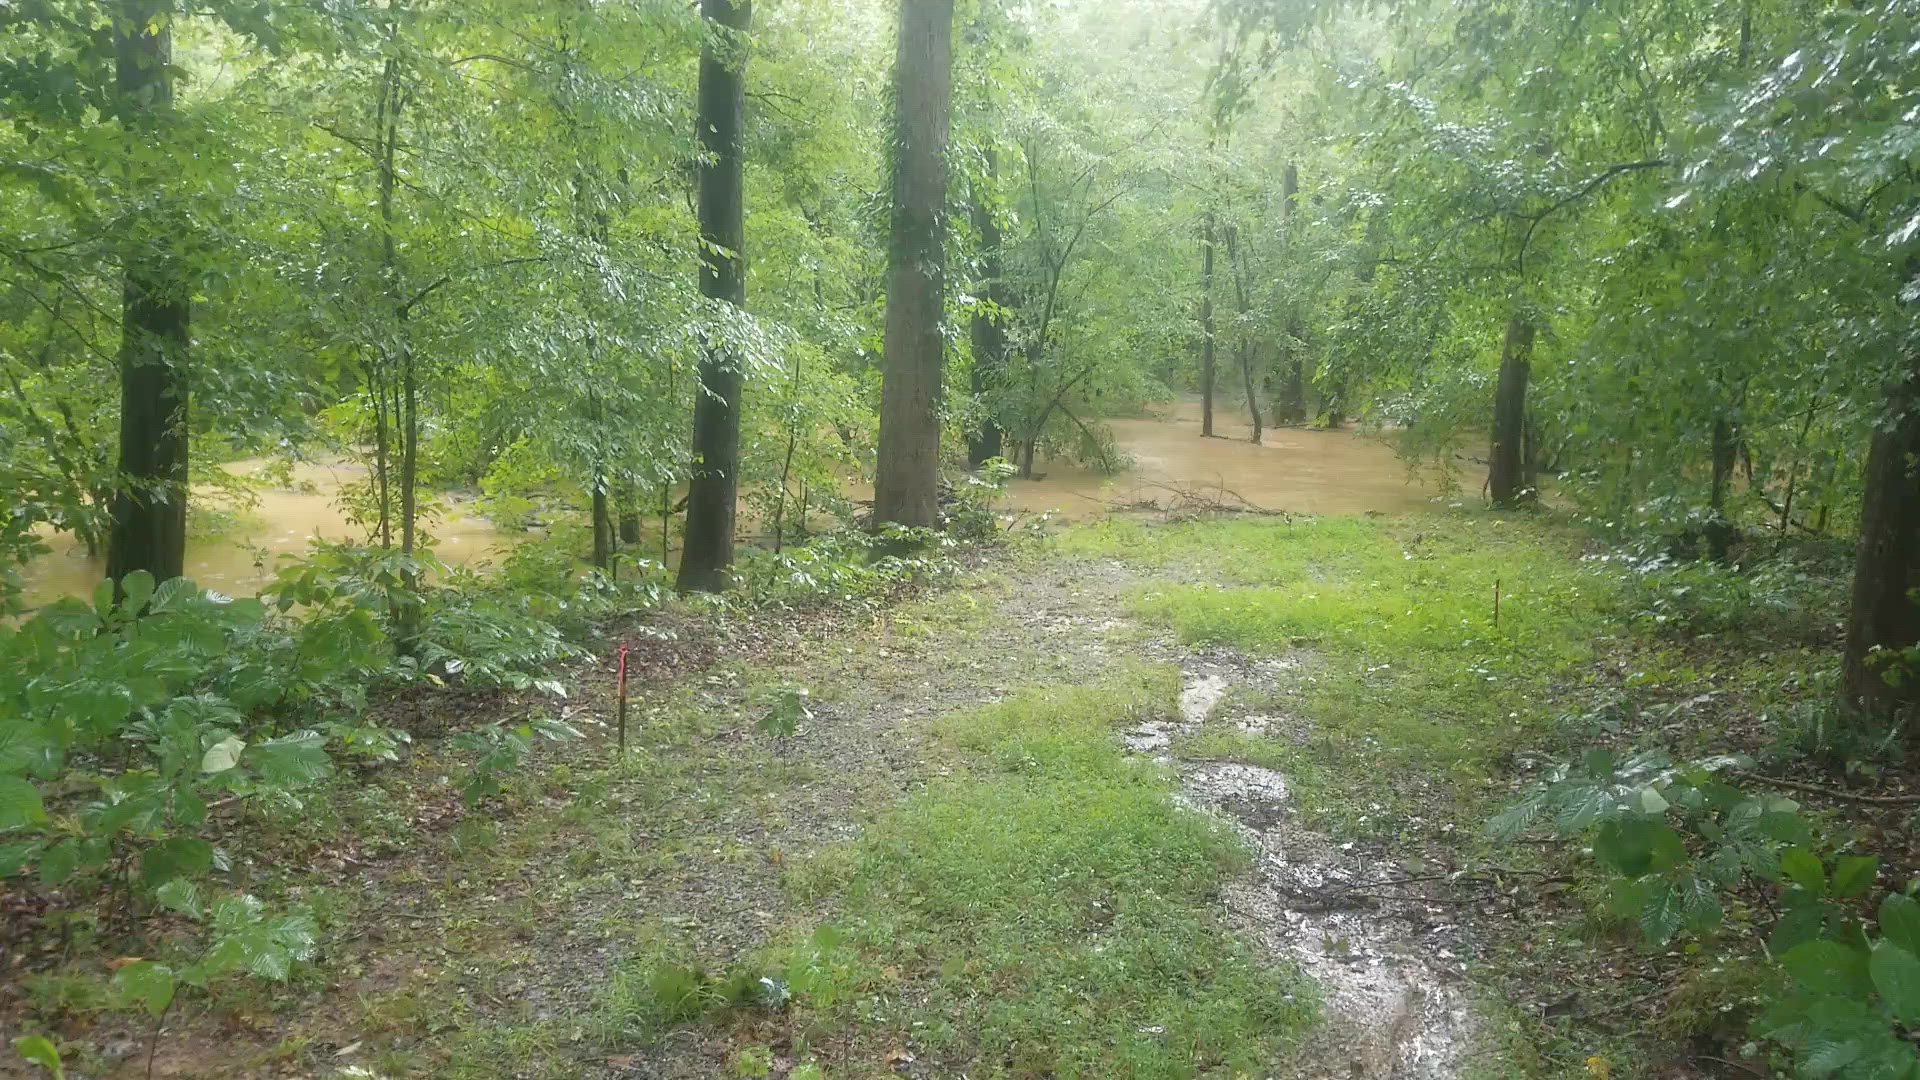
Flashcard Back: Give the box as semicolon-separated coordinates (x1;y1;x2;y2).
660;667;1311;1078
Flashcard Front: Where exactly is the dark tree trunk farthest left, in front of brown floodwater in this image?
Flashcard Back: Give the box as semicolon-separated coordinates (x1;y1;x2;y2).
108;0;192;580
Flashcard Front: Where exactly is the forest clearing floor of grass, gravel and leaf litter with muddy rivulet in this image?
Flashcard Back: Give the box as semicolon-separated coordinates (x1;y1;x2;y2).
0;513;1858;1080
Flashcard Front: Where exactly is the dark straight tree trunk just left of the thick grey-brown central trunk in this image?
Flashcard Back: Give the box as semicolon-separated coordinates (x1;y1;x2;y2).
680;0;753;592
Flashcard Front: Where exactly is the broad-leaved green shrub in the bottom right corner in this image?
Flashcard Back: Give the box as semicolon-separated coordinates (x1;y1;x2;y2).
1490;749;1920;1080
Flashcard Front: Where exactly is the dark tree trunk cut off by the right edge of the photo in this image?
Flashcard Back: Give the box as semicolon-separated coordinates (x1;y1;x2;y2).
1841;354;1920;722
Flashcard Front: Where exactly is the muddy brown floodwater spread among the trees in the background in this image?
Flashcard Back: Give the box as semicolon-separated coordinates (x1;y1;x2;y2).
11;400;1436;607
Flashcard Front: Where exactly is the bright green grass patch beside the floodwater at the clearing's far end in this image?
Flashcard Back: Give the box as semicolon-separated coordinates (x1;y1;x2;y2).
1060;513;1619;778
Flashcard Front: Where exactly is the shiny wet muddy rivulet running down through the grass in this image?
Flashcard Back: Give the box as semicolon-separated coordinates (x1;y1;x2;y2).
1123;661;1473;1080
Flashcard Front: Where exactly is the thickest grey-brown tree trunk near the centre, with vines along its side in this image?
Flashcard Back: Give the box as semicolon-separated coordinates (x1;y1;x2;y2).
874;0;954;528
